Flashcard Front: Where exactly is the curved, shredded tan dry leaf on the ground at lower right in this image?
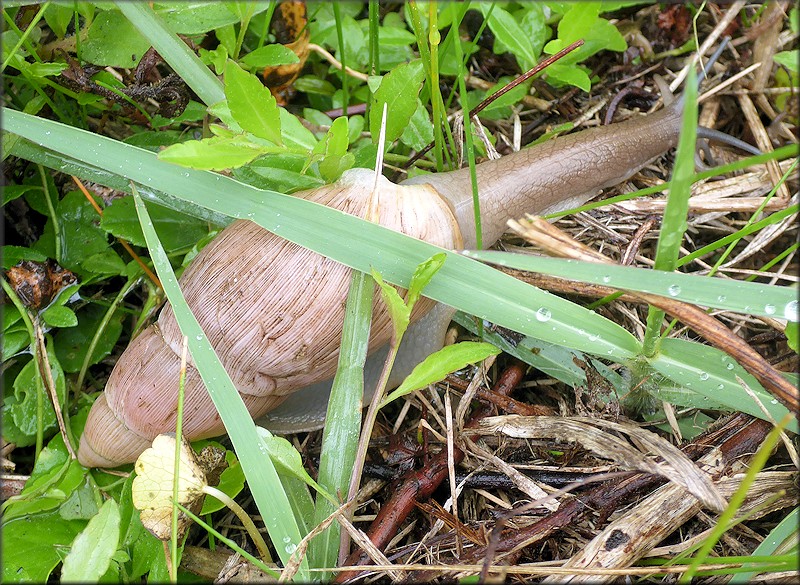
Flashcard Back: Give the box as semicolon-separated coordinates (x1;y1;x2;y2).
479;415;727;512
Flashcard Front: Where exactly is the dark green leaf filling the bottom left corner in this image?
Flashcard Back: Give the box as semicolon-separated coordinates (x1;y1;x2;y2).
2;512;86;583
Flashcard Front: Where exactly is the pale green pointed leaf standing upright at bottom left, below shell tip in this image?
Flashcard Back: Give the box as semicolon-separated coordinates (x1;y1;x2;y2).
61;498;120;583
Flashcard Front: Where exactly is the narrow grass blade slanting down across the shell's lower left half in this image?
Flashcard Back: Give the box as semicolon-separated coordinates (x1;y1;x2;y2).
133;190;310;580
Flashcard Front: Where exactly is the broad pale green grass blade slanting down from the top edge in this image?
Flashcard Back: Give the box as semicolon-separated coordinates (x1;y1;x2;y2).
114;0;225;106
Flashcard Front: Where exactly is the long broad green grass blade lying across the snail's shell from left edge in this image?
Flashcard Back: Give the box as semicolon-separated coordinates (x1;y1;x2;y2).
3;109;640;360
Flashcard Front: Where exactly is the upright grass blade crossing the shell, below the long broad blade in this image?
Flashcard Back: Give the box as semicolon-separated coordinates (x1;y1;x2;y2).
308;271;374;582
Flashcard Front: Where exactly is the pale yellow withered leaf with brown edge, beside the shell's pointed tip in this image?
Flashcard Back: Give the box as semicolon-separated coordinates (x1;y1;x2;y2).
131;433;207;540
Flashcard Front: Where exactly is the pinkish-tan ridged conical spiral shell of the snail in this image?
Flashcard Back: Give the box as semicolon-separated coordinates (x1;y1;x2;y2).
78;169;462;467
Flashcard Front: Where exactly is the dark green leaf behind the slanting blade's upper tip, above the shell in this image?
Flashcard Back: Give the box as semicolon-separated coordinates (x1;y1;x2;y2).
100;197;208;251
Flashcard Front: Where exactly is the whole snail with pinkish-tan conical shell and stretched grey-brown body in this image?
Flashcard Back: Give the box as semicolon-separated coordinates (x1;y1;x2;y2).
78;89;756;467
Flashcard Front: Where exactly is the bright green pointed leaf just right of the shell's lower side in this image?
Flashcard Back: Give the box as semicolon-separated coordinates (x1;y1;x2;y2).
381;341;500;407
